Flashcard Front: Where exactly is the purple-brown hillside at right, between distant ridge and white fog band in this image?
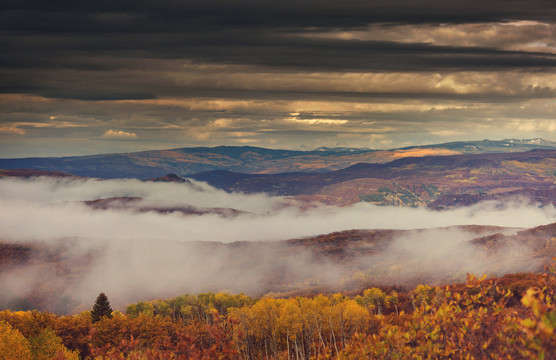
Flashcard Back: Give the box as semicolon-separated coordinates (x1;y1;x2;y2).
191;150;556;205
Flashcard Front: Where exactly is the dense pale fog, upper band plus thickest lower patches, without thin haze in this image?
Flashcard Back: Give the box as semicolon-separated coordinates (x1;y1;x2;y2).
0;178;556;312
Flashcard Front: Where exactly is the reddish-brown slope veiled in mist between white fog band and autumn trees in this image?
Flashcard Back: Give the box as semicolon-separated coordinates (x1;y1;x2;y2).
0;223;556;313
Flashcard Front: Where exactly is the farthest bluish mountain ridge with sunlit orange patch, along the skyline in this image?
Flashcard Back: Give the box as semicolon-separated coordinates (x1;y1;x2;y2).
0;139;556;179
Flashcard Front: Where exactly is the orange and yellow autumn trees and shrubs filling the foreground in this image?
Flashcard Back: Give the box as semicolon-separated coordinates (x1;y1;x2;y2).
0;269;556;360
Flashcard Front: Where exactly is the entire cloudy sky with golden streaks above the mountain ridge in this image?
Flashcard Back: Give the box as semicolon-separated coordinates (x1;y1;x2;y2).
0;0;556;158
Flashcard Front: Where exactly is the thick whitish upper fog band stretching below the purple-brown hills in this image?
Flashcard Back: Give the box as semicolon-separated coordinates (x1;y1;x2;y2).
0;178;556;243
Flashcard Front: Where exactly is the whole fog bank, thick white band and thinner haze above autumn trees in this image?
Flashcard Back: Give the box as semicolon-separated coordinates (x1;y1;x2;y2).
0;178;556;312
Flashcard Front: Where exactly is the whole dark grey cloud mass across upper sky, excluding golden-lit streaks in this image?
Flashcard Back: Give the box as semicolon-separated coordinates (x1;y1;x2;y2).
0;0;556;100
